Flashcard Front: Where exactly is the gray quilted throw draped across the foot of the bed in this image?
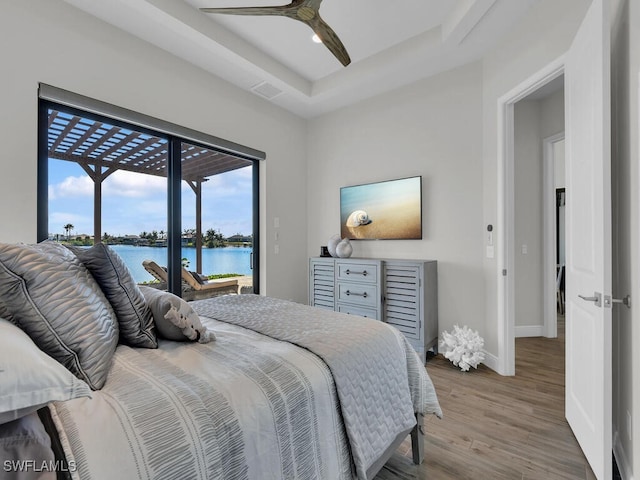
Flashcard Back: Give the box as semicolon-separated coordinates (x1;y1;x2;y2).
193;295;442;478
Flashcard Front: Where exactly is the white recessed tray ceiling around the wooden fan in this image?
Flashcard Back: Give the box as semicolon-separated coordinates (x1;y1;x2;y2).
65;0;538;118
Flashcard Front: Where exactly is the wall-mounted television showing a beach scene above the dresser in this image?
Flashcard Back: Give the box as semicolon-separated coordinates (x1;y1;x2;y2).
340;176;422;240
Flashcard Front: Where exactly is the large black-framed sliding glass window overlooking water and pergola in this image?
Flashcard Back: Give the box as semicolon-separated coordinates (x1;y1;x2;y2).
38;94;258;294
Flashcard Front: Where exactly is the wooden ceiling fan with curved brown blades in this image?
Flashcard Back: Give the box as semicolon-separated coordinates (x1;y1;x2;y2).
200;0;351;67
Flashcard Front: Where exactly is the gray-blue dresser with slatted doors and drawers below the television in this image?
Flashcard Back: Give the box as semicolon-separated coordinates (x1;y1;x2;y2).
309;257;438;361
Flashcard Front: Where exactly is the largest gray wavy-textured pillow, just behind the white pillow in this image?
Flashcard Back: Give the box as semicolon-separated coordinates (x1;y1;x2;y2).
0;241;118;389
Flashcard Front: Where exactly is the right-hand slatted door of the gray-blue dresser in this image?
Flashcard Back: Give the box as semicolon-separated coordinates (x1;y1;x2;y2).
384;263;421;340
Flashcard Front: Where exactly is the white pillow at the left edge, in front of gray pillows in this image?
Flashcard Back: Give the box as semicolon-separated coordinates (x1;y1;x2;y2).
0;319;91;424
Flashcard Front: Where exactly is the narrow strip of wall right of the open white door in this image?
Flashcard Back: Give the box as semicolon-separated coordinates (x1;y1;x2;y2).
611;0;640;479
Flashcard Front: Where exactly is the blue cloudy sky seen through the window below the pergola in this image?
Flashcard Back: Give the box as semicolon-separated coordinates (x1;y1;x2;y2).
49;160;252;236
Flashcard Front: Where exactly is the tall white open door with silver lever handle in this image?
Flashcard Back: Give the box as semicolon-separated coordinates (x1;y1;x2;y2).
565;0;612;480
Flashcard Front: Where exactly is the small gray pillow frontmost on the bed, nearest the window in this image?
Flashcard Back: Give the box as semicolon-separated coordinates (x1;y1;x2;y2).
140;286;216;343
